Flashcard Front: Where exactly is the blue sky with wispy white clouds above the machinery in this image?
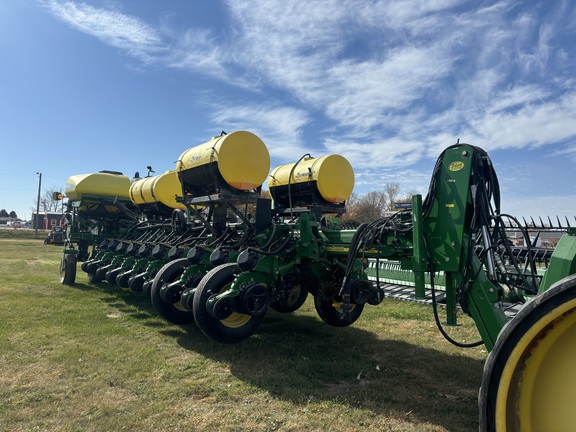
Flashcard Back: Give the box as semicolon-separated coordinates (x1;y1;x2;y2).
0;0;576;221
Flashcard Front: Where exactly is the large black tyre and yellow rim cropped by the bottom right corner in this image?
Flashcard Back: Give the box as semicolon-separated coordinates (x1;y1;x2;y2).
479;275;576;431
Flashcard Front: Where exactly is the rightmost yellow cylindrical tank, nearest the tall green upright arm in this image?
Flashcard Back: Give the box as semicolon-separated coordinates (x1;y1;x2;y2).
268;155;354;207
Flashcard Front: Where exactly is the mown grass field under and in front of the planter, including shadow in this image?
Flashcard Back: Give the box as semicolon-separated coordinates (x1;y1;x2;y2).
0;230;486;432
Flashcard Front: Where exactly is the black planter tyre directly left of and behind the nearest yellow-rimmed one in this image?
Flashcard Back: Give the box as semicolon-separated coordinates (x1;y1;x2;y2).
150;258;194;325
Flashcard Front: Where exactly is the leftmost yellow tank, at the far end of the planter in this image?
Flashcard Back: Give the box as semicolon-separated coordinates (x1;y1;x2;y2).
64;171;130;201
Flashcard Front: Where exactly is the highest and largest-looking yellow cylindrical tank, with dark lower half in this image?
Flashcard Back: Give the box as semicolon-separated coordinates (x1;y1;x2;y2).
176;131;270;195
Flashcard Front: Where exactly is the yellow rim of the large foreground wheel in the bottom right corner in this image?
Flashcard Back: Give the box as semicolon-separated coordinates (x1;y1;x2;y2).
496;299;576;432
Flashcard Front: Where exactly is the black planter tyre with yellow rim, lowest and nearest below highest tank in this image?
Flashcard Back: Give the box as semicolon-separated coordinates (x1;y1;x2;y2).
192;263;265;344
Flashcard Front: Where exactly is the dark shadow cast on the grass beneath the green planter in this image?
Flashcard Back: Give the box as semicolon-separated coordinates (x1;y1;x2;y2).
77;283;483;430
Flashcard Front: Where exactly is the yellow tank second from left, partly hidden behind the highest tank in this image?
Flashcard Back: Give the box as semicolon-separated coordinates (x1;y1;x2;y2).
130;171;186;210
